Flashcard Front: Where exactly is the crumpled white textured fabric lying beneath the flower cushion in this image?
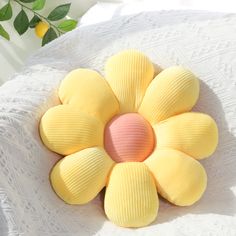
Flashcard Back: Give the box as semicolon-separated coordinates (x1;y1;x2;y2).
0;6;236;236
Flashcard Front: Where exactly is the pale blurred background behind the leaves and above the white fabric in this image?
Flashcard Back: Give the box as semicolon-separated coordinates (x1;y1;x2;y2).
0;0;236;84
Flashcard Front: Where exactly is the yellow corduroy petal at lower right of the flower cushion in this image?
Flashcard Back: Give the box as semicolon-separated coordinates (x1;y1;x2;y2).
145;149;207;206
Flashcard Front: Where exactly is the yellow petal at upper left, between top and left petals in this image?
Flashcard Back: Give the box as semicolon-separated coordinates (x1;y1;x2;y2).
59;69;119;123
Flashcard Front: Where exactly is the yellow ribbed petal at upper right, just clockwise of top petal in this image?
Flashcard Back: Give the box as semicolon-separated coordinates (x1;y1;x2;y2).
139;66;199;124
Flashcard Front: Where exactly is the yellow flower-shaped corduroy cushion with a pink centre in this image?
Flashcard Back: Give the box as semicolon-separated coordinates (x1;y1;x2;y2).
40;50;218;227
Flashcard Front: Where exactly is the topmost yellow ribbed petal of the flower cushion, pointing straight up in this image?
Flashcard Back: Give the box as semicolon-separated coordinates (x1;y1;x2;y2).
105;50;154;113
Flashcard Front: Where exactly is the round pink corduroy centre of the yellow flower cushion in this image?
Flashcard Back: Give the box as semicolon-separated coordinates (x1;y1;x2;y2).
104;113;154;162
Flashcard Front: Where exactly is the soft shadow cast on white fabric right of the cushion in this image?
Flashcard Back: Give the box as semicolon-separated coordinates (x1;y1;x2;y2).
153;81;236;224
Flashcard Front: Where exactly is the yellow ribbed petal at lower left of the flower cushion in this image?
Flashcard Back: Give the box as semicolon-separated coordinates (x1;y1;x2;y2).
50;147;114;204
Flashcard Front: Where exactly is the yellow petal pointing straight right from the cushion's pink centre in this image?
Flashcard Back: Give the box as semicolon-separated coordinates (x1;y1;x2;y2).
154;112;218;159
